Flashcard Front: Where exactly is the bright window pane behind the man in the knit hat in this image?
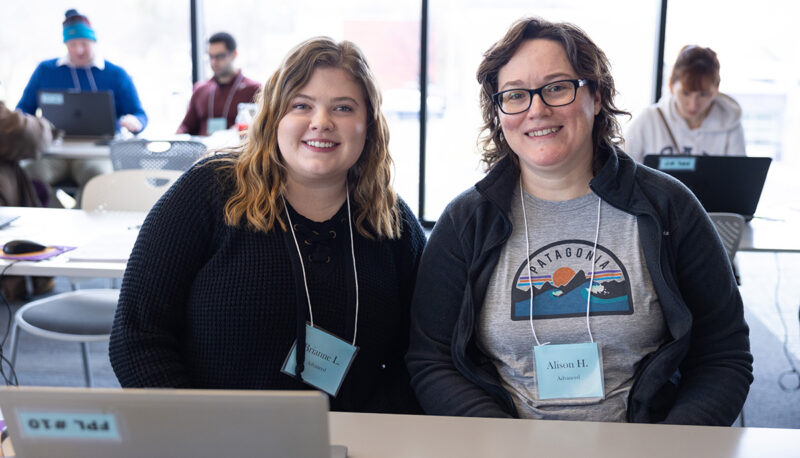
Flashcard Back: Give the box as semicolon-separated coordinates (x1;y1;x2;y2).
0;0;192;137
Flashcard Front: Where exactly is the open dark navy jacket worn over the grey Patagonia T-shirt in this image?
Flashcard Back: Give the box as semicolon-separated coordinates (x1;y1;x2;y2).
406;146;753;425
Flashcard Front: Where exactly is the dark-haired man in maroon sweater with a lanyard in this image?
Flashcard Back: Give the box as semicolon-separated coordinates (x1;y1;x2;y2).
178;32;260;135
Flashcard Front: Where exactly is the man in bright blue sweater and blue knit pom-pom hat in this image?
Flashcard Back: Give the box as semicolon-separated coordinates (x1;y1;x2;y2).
17;9;147;188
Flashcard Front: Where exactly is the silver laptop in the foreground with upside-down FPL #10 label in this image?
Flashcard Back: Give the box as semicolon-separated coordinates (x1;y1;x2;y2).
0;387;347;458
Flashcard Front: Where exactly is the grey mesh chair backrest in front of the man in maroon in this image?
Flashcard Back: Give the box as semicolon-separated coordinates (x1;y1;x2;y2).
110;140;206;171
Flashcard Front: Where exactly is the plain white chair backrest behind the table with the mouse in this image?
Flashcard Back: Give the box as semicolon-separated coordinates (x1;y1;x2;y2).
81;169;183;211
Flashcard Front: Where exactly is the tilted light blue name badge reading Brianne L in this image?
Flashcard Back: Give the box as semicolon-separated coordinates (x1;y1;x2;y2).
281;324;358;397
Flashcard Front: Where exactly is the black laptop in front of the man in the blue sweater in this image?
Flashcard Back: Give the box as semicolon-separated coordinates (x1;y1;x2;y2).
38;89;117;137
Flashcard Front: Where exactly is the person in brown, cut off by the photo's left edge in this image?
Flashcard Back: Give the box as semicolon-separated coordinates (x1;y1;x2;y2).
0;100;56;302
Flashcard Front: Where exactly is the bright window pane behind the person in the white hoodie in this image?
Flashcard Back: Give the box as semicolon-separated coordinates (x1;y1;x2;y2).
663;0;800;211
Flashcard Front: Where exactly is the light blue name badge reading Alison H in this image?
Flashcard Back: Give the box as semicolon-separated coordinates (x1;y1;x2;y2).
533;342;605;399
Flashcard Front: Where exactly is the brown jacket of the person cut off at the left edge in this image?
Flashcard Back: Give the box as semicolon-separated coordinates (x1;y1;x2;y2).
0;102;54;207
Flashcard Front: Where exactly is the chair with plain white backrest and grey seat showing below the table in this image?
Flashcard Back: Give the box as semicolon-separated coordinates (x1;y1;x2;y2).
9;170;183;387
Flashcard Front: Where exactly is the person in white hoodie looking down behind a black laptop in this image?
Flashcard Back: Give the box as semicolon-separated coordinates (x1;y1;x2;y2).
625;45;745;162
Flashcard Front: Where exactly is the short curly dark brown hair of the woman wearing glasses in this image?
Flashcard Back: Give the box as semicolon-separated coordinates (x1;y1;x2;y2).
476;17;630;171
